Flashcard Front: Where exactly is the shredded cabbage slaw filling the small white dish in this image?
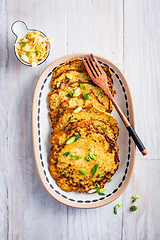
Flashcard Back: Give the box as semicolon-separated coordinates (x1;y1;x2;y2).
14;31;53;67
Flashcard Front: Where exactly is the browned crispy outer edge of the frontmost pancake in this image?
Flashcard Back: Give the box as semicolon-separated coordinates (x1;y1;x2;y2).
49;121;119;193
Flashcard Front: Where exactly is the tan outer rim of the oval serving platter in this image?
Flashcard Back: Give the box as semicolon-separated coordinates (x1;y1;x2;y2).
32;53;136;209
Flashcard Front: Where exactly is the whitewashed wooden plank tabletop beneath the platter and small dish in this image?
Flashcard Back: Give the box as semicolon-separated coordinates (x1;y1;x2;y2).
0;0;160;240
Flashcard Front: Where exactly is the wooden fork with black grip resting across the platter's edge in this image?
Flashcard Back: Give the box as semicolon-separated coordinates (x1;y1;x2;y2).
83;54;147;155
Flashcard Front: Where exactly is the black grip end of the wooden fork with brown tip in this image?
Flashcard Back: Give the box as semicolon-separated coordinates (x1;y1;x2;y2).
126;125;147;155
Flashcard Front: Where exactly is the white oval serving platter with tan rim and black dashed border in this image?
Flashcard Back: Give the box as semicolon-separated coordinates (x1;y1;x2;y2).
32;53;136;208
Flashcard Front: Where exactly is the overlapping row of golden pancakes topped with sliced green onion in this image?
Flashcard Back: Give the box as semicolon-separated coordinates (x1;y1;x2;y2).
48;58;119;193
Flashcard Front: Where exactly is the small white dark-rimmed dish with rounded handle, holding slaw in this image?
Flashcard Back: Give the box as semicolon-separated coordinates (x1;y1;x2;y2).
11;20;51;67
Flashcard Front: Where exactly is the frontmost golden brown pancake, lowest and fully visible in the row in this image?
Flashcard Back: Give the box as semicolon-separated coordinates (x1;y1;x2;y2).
49;121;119;193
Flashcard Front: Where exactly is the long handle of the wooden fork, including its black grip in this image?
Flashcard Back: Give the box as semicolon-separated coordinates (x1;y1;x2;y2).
106;91;147;155
